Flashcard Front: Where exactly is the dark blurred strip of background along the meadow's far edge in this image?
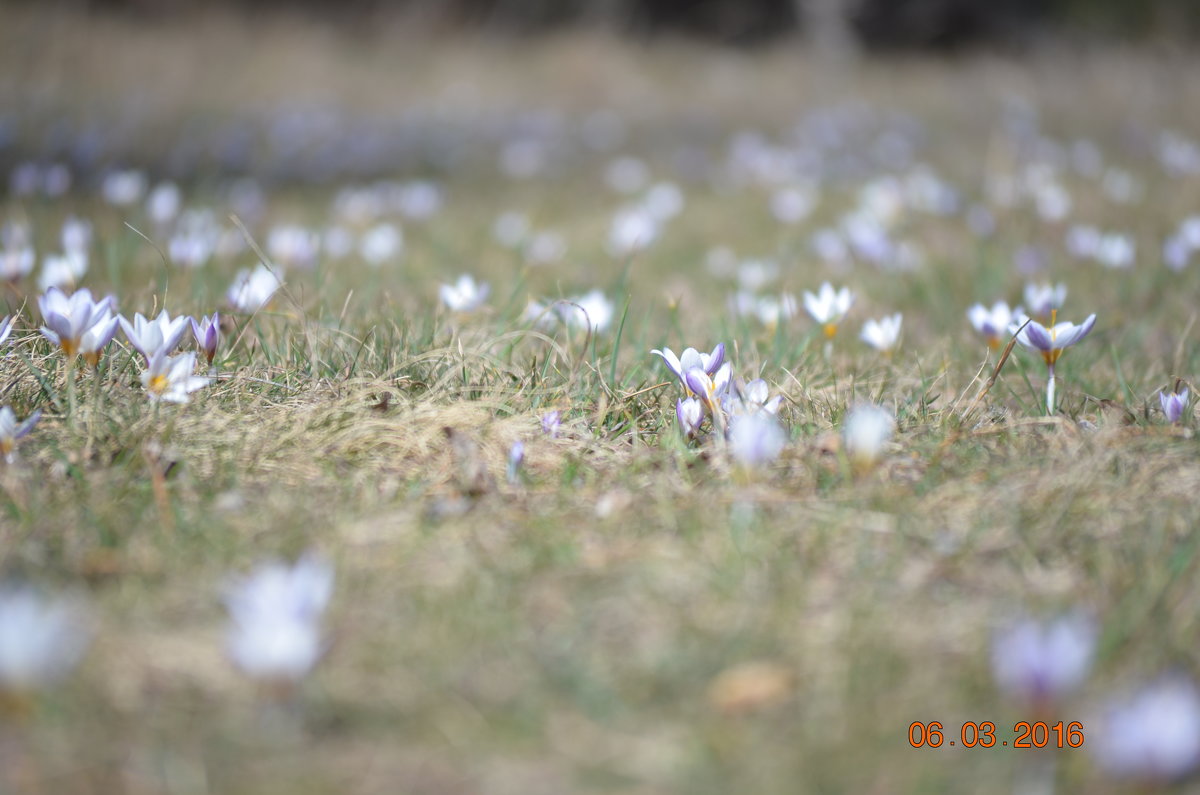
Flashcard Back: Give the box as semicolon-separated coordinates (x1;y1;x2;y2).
18;0;1200;49
